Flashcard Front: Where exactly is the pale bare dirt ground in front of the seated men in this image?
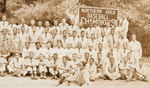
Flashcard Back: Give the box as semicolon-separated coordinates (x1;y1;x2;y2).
0;60;150;88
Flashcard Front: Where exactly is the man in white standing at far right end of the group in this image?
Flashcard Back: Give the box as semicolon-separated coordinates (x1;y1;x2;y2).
129;34;142;64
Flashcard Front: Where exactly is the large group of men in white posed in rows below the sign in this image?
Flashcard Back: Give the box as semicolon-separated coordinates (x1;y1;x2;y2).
0;15;147;85
